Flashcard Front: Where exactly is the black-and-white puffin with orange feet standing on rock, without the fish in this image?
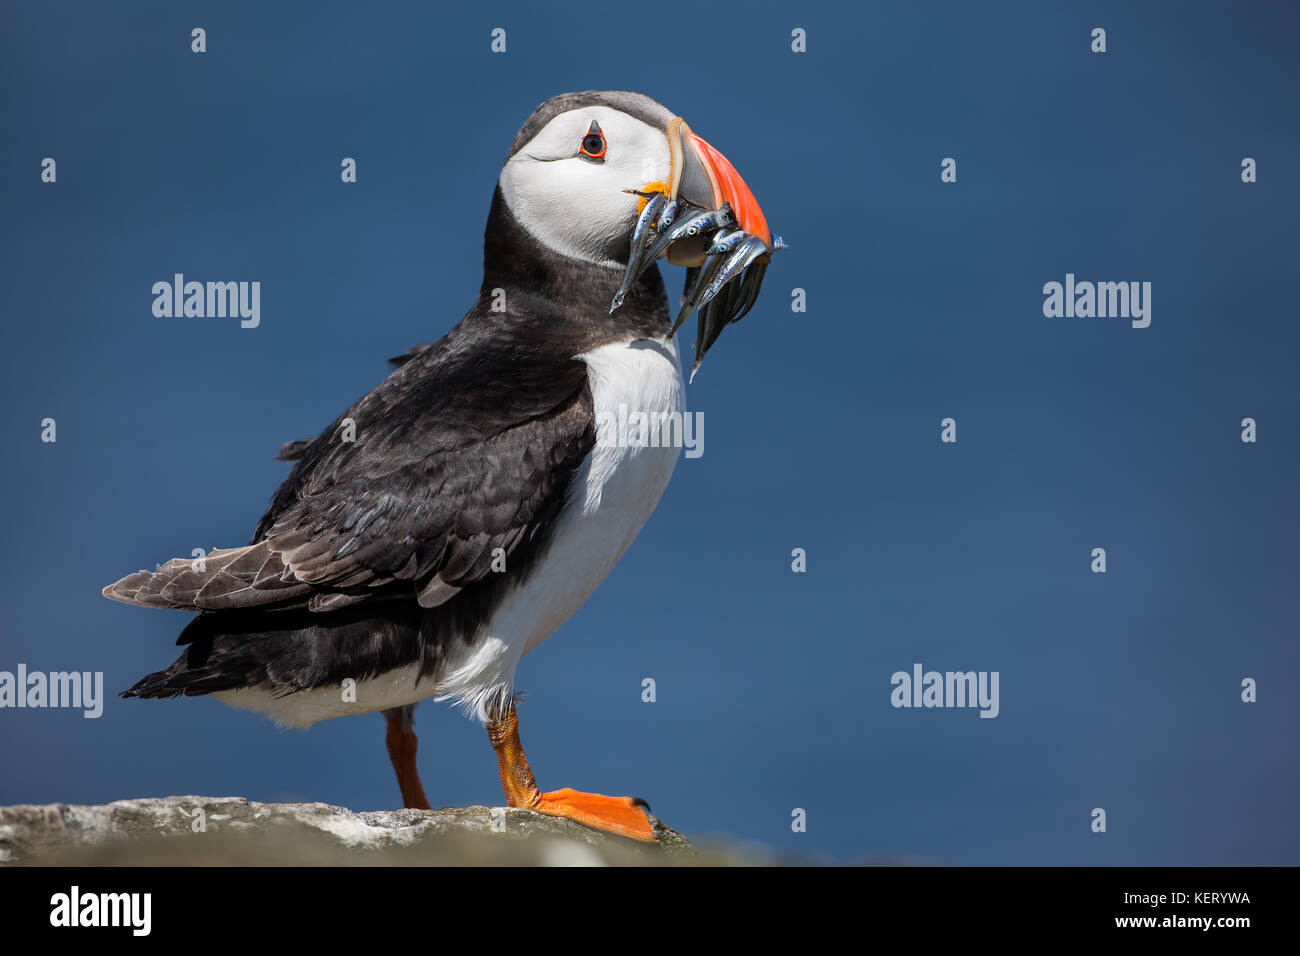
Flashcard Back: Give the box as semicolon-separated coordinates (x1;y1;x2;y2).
103;91;771;842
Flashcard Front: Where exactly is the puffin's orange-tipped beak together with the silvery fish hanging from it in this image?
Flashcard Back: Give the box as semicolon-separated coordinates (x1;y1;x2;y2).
610;116;785;378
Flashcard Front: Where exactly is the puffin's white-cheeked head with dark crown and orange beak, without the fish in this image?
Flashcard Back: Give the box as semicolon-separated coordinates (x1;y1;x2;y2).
501;90;772;268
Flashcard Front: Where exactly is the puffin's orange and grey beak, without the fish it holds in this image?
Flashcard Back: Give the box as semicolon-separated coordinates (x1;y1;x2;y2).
668;116;772;265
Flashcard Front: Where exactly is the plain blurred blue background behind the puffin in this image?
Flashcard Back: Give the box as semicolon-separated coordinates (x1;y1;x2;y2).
0;3;1300;864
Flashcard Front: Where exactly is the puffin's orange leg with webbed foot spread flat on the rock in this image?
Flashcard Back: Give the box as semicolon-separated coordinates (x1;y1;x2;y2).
488;705;655;843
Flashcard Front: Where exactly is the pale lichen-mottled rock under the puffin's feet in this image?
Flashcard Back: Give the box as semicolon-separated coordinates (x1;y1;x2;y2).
0;796;697;866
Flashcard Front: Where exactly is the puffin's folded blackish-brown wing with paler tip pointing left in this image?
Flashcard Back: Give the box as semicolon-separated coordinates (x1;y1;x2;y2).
104;339;595;610
